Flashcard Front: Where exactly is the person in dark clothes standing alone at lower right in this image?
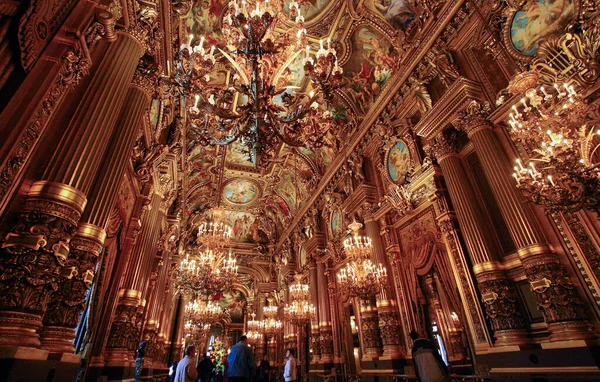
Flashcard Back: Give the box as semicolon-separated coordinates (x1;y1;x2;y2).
409;330;450;382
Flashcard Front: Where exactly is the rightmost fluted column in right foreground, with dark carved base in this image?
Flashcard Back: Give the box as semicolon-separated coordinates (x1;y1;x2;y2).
455;101;592;340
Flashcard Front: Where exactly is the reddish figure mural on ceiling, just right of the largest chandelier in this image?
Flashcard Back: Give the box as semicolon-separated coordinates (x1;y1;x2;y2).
344;25;396;110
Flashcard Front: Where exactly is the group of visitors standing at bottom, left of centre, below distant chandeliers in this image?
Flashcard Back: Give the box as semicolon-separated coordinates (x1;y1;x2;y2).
169;336;296;382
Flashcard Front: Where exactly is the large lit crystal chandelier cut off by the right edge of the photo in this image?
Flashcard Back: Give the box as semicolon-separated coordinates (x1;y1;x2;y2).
507;72;600;216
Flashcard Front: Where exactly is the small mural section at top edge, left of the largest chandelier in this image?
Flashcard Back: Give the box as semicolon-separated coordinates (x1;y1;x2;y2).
184;0;227;44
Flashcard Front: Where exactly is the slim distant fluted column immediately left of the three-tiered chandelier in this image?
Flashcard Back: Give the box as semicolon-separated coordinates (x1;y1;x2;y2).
316;261;333;363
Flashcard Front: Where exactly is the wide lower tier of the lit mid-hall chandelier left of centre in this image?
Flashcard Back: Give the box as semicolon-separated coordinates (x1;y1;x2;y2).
175;248;238;296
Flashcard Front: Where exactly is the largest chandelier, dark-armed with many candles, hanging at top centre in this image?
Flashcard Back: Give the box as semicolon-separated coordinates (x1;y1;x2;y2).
175;0;343;167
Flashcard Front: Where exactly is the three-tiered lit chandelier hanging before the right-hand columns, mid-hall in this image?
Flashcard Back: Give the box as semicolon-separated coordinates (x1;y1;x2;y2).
337;221;387;300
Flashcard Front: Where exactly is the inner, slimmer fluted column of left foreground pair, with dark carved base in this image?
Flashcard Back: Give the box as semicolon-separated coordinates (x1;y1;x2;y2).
41;80;150;353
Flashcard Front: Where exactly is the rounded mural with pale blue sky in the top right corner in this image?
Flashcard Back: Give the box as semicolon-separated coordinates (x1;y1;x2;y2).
510;0;575;56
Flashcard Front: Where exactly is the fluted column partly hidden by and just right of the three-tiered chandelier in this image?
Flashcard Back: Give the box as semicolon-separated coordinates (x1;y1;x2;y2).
364;213;403;359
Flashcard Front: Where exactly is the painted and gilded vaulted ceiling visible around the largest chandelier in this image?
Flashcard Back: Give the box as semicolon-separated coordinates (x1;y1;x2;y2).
180;0;400;249
